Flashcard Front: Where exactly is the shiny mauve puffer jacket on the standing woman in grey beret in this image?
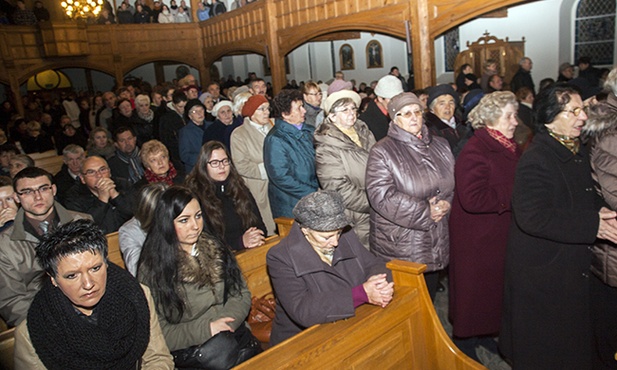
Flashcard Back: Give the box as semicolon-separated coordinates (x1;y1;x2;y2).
366;122;454;271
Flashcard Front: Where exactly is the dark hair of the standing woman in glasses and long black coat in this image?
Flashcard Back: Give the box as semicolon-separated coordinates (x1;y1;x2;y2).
533;82;580;132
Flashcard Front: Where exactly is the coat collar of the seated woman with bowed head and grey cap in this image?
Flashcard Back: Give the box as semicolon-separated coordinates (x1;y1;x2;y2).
287;223;358;276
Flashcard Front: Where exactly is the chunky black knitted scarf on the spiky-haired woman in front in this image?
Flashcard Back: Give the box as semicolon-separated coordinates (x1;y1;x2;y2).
28;263;150;370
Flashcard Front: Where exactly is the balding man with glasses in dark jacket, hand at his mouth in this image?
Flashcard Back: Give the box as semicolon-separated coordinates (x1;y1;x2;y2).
66;156;133;234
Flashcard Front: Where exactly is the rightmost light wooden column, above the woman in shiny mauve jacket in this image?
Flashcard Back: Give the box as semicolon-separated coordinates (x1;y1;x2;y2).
410;0;436;89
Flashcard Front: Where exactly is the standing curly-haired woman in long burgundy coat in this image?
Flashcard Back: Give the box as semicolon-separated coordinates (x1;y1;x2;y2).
449;92;521;359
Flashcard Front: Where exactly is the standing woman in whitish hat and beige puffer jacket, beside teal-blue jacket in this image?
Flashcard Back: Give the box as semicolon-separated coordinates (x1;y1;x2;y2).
314;90;375;249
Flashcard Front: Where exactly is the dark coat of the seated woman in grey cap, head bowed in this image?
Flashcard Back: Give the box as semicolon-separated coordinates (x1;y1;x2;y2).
267;224;387;345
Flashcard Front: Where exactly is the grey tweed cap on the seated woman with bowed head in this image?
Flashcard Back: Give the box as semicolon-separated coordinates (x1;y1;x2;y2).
293;190;351;231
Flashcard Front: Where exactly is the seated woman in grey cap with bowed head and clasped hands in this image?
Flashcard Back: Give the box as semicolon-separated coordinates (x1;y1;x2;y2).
267;191;394;345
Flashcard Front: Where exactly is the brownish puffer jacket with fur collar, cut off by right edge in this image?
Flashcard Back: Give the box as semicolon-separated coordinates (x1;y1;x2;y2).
583;93;617;287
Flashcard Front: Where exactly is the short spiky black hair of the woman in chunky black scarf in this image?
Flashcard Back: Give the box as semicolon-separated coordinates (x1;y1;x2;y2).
35;219;107;277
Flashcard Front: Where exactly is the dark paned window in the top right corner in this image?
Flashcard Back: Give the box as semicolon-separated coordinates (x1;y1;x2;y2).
574;0;616;65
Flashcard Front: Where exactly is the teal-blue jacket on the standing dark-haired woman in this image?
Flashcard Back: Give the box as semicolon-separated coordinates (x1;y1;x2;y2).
264;119;319;218
